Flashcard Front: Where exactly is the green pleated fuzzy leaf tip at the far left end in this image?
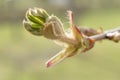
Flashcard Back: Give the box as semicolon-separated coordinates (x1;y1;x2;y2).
23;8;49;36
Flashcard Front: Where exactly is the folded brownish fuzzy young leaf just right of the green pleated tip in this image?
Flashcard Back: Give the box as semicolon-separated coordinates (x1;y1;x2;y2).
43;15;65;39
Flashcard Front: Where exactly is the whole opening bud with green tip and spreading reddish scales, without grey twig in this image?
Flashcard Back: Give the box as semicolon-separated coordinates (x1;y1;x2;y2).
23;8;95;67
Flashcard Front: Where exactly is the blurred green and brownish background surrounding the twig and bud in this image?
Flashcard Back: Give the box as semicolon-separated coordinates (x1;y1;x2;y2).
0;0;120;80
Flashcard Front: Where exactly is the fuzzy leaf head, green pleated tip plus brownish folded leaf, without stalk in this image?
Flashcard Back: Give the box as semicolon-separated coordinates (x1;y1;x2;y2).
23;8;65;39
